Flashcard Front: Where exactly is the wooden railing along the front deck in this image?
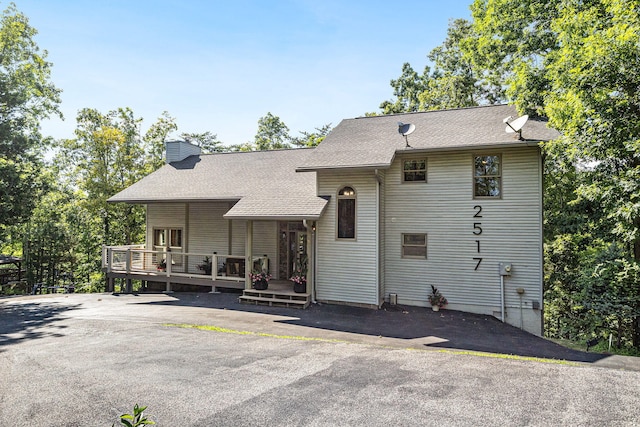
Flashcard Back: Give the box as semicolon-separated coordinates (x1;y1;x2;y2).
102;245;269;282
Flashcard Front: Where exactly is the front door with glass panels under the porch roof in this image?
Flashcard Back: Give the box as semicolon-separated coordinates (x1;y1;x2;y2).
278;221;307;280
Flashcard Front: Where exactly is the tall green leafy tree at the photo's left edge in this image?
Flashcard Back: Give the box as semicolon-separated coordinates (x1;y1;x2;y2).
0;4;61;227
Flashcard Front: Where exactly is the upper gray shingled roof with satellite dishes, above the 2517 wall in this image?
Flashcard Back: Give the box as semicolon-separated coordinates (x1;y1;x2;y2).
298;105;559;171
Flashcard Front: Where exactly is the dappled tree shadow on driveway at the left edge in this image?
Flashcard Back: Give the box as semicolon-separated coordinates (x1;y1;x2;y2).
0;298;78;352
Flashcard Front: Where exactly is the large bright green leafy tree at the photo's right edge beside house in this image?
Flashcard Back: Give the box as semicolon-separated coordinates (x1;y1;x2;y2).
472;0;640;348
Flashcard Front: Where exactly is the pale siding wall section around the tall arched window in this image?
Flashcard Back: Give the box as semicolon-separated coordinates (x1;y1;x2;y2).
316;170;379;305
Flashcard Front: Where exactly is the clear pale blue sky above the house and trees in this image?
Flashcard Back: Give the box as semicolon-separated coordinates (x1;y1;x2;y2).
11;0;471;144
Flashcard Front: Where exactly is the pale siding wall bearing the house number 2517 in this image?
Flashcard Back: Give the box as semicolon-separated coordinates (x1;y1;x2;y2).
385;148;542;329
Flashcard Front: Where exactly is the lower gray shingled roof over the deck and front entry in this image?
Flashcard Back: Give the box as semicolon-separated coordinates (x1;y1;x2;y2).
109;149;327;219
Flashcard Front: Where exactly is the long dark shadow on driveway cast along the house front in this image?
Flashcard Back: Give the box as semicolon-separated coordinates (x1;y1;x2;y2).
136;293;609;363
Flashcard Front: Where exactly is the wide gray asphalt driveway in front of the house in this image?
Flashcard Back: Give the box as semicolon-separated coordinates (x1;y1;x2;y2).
0;293;640;426
